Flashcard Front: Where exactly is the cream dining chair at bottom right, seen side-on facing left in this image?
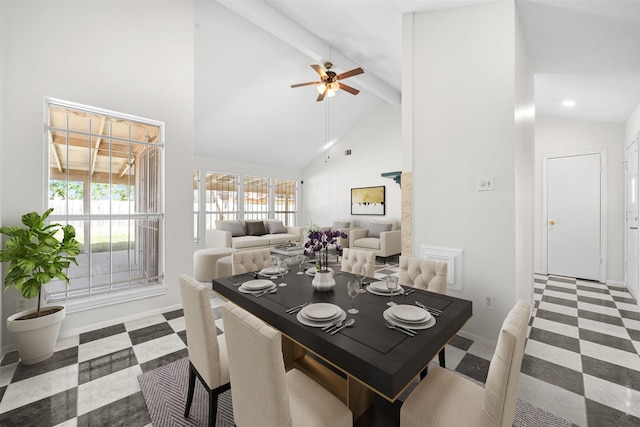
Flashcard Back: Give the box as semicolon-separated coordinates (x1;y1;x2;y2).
400;301;531;427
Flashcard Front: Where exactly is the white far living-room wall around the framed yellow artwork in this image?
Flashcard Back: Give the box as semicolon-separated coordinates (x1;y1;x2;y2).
301;105;402;231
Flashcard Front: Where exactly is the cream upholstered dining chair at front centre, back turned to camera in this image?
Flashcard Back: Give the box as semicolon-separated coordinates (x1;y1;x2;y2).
222;303;353;427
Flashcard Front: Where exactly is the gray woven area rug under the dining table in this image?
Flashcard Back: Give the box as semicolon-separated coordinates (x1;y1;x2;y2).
138;358;572;427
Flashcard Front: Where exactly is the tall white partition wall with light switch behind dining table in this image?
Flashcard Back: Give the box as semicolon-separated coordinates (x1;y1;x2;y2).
403;2;533;341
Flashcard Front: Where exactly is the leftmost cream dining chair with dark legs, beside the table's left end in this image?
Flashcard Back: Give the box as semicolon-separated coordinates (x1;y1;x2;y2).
180;274;230;427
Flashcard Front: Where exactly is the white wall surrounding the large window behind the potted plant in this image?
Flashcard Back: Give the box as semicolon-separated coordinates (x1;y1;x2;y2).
0;0;194;346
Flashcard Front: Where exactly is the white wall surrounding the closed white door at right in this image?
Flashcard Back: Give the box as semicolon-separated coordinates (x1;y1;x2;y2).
535;116;625;282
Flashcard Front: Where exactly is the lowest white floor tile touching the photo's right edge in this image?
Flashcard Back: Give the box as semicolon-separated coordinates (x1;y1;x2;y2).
584;374;640;418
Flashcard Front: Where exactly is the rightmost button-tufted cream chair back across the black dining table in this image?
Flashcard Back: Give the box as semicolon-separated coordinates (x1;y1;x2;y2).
398;256;447;294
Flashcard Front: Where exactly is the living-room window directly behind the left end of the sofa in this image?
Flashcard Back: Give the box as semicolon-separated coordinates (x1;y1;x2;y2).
205;172;239;229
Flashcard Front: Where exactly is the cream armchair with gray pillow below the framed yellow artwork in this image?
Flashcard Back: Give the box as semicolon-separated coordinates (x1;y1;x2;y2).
349;221;402;258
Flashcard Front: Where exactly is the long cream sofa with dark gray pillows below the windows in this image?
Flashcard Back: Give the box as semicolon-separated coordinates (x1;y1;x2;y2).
206;219;304;251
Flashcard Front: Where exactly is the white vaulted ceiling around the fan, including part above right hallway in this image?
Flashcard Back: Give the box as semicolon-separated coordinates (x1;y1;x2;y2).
195;0;640;168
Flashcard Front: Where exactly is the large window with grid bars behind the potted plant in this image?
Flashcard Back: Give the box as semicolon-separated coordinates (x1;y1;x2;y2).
45;98;166;307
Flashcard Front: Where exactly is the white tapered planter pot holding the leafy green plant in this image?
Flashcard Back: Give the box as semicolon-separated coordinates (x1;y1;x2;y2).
7;305;67;365
